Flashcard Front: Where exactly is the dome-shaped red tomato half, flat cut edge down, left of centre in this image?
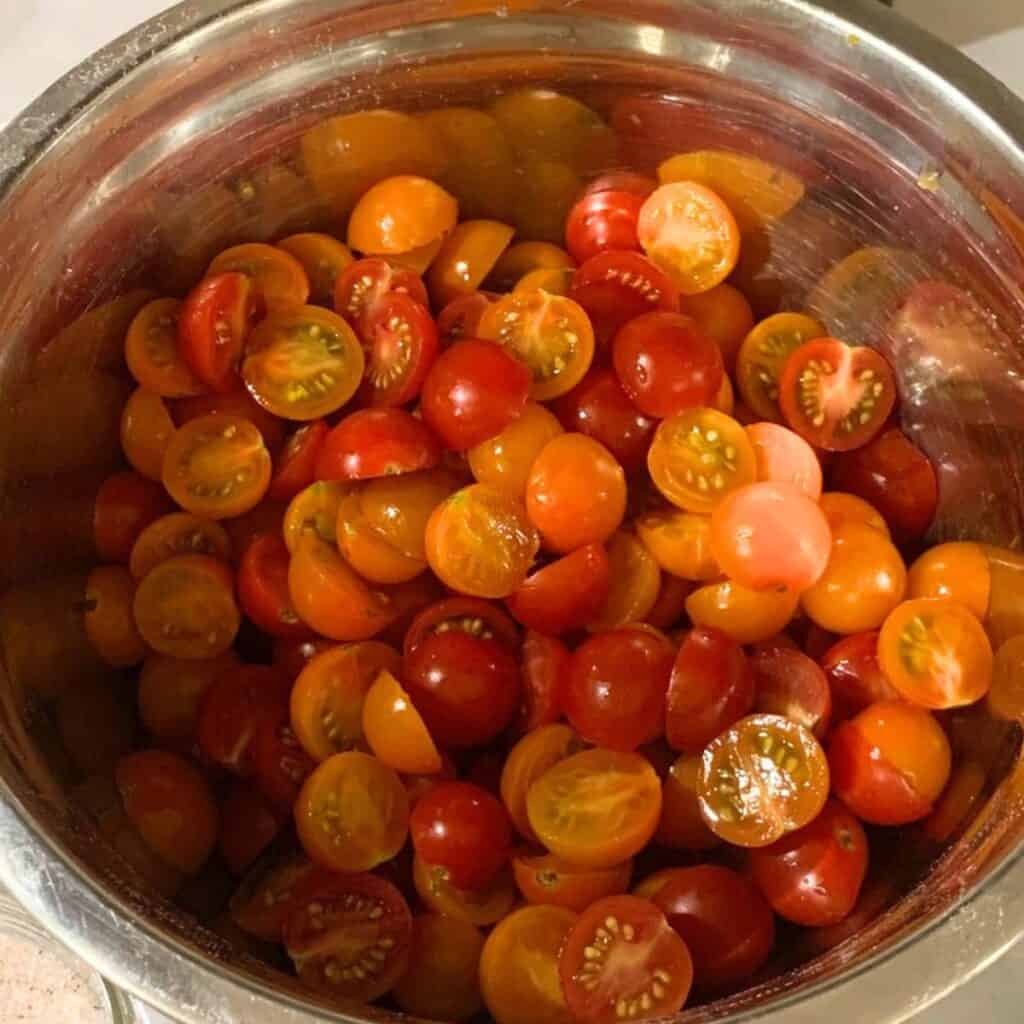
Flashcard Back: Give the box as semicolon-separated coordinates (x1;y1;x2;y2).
316;409;441;480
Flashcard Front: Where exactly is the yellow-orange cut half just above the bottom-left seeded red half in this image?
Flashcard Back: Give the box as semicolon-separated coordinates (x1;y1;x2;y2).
295;751;409;871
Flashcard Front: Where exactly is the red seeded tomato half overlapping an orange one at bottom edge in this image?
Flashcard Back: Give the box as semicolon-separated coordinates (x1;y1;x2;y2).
559;896;693;1024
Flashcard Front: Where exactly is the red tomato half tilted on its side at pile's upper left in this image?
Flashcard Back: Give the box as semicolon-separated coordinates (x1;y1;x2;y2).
178;271;260;392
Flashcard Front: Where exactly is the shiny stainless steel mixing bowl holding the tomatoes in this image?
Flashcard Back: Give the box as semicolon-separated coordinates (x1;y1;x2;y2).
0;0;1024;1024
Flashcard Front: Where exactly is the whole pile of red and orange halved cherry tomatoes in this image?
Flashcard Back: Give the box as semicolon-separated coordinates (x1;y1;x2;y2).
77;149;1015;1024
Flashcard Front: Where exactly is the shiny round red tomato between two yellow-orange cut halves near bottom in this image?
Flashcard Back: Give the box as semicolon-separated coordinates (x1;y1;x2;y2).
409;782;512;890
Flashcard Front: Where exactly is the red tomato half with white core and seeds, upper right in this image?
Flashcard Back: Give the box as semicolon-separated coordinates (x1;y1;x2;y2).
778;338;896;452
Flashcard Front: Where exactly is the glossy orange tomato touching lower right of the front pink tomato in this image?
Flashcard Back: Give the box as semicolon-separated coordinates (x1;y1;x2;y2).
801;522;906;633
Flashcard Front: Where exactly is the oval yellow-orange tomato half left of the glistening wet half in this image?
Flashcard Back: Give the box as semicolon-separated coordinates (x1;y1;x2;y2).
526;748;662;867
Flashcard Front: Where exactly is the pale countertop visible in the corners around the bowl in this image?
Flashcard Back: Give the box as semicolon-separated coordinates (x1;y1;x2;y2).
0;0;1024;1024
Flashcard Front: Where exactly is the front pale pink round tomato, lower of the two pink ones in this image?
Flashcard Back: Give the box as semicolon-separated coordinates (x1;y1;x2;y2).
711;482;831;592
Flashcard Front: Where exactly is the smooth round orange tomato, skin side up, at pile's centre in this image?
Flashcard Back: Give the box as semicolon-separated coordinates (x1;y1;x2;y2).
526;433;626;554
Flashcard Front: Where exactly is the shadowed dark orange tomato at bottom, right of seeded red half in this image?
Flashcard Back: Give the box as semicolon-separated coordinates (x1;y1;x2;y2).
392;913;483;1024
